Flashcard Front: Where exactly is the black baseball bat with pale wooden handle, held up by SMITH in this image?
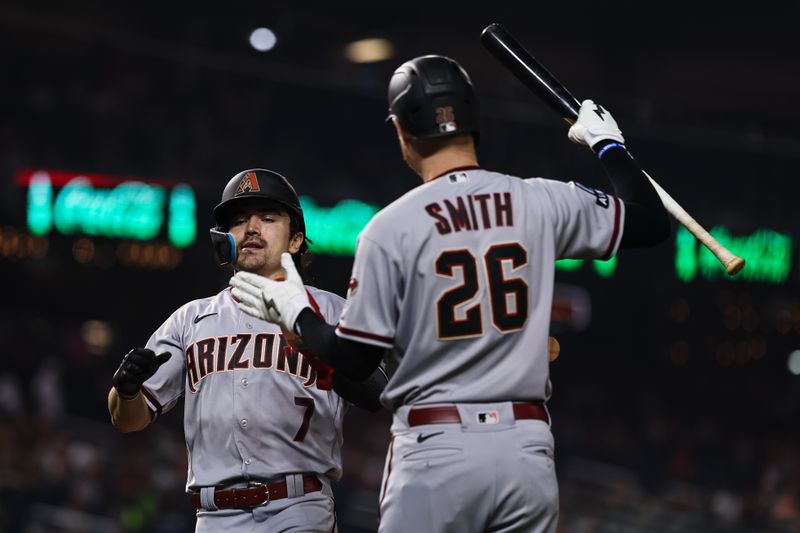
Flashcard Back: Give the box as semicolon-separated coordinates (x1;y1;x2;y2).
481;23;744;276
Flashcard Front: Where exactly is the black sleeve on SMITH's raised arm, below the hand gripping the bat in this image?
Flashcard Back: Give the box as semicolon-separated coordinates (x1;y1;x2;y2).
592;141;670;248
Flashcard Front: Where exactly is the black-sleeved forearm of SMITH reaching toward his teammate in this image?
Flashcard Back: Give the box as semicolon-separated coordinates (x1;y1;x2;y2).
297;308;385;381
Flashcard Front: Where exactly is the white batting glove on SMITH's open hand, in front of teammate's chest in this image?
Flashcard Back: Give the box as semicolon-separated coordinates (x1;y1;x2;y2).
230;252;311;331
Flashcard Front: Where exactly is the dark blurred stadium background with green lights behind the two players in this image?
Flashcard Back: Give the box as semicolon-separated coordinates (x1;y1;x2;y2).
0;0;800;533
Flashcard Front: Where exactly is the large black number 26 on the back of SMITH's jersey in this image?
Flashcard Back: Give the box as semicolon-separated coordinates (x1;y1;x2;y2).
434;242;528;340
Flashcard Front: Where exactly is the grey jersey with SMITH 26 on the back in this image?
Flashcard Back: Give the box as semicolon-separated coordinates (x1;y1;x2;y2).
336;169;624;409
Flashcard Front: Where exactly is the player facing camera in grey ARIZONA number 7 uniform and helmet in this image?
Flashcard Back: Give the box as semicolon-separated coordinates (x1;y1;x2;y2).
108;169;386;533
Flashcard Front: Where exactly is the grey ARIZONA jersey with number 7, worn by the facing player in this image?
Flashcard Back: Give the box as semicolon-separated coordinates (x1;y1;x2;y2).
142;287;344;490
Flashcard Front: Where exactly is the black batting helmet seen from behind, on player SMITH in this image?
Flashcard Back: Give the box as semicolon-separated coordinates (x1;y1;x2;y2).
389;55;478;141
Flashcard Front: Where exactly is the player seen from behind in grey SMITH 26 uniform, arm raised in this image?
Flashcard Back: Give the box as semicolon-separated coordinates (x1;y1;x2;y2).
231;55;670;533
